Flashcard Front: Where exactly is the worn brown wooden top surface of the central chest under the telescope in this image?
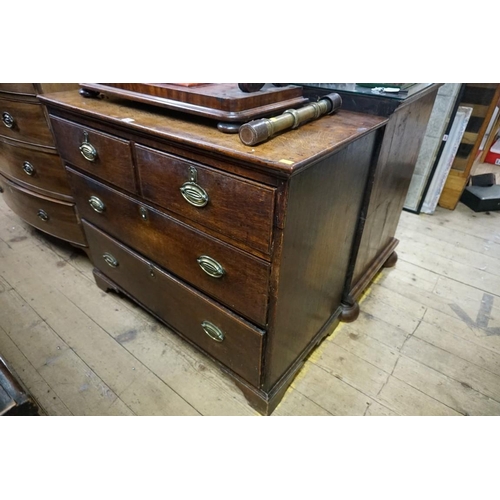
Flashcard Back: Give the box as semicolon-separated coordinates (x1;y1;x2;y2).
40;91;387;176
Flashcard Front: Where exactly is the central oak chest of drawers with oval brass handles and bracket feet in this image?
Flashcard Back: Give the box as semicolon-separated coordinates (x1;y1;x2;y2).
41;92;386;414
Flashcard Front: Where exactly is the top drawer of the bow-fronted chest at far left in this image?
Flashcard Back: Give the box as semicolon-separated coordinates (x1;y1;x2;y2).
0;97;54;147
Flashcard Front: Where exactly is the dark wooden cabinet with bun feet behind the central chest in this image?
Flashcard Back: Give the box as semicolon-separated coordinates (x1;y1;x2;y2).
305;83;440;321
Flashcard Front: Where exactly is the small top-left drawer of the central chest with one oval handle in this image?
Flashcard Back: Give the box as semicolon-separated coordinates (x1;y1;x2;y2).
51;117;137;193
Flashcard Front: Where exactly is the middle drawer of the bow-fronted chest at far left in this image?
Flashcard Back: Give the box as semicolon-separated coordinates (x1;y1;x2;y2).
0;141;71;197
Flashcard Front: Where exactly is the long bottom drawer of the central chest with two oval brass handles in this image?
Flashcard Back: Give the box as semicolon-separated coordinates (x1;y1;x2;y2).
83;221;263;387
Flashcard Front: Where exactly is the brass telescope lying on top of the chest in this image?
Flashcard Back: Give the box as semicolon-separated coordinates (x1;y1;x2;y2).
239;93;342;146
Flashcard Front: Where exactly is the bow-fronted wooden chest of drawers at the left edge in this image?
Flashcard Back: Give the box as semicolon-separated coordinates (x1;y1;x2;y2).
0;83;86;246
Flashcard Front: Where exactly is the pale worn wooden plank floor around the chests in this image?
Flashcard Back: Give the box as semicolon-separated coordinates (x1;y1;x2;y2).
0;196;500;416
